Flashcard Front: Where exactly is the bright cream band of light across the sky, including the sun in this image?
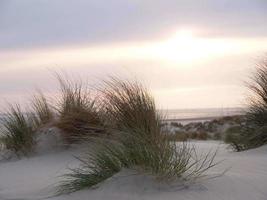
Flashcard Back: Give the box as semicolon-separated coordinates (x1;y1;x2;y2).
0;30;267;68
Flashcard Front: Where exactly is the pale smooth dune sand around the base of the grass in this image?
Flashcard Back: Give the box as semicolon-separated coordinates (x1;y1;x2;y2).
0;141;267;200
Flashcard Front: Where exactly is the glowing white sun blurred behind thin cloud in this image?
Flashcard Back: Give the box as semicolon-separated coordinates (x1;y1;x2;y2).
153;29;234;64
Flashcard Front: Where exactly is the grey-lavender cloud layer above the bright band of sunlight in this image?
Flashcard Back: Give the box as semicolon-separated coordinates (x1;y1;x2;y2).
0;0;267;49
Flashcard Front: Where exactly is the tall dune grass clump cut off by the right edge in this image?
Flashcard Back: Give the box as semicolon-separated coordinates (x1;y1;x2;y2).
226;55;267;151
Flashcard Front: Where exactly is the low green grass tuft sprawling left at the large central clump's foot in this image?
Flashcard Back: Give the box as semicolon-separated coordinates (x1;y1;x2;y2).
57;141;128;194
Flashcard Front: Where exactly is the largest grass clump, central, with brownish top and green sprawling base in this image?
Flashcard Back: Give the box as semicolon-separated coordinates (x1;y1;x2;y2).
59;78;222;192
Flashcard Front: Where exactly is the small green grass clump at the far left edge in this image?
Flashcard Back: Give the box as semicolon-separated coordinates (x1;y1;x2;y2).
1;105;35;156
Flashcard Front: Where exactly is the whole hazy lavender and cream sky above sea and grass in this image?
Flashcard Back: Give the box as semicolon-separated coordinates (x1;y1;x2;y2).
0;0;267;109
